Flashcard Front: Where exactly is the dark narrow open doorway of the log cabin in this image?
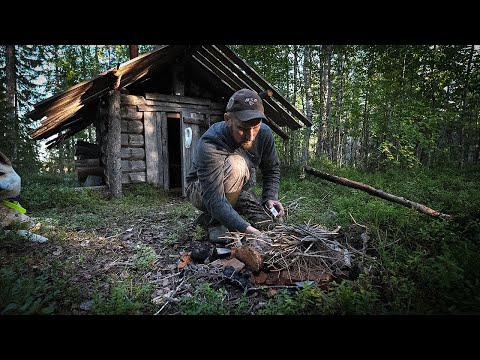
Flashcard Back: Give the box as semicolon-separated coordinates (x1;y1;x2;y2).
167;113;182;191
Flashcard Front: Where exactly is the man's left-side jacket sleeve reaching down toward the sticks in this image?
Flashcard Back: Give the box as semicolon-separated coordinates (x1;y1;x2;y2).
197;141;250;232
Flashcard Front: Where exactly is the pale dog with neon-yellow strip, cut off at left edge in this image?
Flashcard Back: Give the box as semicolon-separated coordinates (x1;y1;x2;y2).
0;151;47;242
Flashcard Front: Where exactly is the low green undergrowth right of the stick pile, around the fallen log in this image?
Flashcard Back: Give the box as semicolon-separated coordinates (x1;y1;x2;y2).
280;163;480;314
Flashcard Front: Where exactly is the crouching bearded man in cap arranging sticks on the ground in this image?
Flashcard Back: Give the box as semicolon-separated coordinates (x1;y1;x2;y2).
186;89;284;234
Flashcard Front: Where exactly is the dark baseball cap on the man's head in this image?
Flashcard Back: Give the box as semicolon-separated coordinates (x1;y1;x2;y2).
225;89;266;121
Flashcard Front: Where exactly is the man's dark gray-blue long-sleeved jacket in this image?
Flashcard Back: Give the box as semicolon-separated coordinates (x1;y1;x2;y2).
186;121;280;232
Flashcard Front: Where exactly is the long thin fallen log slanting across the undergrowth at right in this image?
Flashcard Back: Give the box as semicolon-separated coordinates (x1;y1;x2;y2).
305;166;452;220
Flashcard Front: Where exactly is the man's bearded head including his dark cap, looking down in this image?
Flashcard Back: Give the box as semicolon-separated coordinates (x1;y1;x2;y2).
224;89;266;150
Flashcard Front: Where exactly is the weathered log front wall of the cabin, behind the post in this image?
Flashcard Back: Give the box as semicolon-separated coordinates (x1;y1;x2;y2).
95;93;224;195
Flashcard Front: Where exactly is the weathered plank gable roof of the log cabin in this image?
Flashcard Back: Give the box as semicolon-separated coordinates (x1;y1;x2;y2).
26;45;312;148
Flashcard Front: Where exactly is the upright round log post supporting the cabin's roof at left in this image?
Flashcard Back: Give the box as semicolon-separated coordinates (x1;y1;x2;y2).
106;89;122;197
